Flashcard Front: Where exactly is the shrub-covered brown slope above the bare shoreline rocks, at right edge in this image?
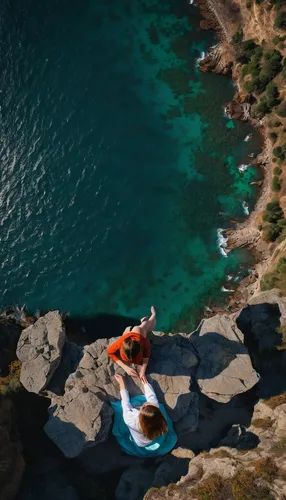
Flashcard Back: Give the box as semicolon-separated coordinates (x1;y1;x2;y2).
232;0;286;296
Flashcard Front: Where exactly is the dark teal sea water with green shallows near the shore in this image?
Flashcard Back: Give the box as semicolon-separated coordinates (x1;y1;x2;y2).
0;0;261;331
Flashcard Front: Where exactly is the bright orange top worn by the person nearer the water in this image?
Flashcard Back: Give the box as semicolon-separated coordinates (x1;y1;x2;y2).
107;332;150;365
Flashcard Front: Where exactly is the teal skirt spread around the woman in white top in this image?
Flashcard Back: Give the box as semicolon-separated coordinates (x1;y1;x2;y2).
111;396;177;458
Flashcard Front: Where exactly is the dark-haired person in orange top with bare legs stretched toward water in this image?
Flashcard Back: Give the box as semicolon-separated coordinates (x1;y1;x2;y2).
107;306;156;380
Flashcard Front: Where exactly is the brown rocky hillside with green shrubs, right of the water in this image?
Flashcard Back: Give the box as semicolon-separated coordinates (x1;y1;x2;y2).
199;0;286;308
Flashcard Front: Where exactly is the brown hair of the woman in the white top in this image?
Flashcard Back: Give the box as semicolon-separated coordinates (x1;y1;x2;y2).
139;404;168;441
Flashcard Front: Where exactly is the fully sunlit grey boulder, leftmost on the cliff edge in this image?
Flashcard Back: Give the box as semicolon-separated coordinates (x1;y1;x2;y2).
17;311;66;394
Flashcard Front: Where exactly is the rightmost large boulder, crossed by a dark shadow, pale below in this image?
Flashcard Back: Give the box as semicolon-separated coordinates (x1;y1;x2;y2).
191;315;259;403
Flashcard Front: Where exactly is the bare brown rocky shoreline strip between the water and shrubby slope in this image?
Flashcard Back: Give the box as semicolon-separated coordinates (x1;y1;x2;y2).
198;0;273;311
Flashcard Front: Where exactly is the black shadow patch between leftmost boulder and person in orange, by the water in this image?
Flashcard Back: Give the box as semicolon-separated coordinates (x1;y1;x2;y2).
65;313;140;345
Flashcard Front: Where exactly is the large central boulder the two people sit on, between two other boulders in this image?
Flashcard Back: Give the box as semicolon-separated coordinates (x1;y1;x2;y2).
45;334;198;457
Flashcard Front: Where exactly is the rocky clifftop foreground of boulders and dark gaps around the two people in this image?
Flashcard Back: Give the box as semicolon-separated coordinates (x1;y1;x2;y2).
0;290;286;500
